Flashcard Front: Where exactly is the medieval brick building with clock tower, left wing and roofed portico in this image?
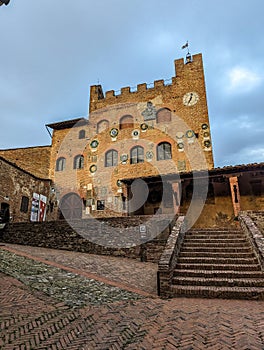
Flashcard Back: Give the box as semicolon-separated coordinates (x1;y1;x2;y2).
0;54;264;226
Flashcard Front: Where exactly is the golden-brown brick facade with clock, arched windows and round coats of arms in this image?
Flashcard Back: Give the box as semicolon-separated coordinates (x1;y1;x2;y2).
48;54;213;216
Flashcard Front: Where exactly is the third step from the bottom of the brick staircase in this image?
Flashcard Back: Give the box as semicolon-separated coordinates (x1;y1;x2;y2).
174;269;264;279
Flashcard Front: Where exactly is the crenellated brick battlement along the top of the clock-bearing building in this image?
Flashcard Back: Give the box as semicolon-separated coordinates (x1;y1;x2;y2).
90;54;203;112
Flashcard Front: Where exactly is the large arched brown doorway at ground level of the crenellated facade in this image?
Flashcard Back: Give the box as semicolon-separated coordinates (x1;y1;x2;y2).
59;193;83;220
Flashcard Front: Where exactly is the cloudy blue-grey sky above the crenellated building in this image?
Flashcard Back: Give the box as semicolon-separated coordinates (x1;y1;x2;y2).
0;0;264;167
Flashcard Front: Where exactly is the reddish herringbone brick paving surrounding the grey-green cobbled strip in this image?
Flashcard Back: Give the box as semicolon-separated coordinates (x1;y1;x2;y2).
0;245;264;350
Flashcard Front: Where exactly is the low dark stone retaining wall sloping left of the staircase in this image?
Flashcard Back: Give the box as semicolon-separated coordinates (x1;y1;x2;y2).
2;217;174;263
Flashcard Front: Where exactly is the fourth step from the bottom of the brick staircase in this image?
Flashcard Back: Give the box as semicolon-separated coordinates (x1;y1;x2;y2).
175;263;261;271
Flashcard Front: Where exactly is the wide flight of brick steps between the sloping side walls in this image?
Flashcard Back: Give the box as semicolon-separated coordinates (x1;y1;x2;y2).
171;229;264;299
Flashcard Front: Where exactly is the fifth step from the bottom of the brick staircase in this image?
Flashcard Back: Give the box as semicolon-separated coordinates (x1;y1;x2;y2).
178;255;258;265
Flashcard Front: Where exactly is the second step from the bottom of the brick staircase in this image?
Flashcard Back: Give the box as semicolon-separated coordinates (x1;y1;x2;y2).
172;276;264;287
